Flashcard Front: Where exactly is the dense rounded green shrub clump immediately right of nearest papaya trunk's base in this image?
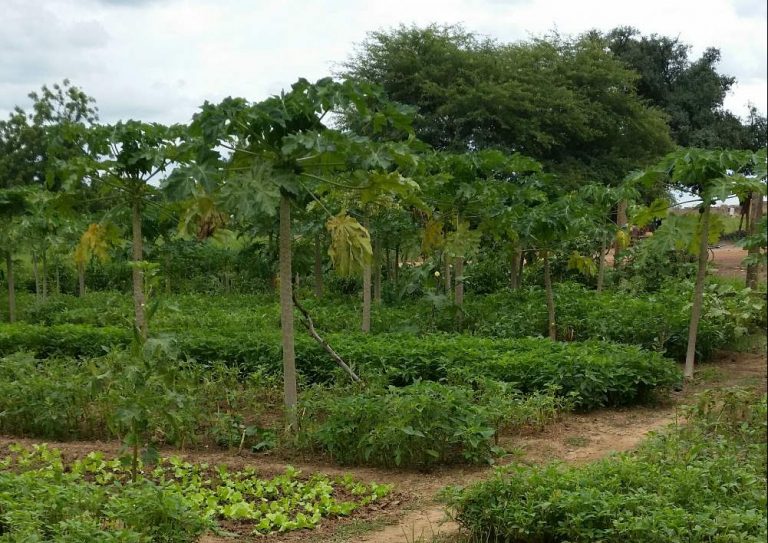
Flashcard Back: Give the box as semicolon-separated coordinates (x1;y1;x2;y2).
300;382;494;469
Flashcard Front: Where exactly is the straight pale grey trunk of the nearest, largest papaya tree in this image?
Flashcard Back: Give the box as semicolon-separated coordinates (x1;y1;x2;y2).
279;194;298;432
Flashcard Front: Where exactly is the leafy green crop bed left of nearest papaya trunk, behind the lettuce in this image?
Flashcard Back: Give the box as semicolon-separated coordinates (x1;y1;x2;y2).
0;351;273;448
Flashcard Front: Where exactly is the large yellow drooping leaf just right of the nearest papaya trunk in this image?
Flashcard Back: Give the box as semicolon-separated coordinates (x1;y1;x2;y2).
325;213;373;276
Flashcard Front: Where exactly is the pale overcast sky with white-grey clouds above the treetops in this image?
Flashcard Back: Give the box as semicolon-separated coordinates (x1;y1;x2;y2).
0;0;768;123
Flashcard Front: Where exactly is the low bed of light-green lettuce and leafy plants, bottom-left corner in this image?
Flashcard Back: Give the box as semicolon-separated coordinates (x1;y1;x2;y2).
0;445;390;543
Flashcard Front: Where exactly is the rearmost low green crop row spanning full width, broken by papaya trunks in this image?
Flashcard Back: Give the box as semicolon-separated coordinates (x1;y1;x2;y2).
6;282;766;359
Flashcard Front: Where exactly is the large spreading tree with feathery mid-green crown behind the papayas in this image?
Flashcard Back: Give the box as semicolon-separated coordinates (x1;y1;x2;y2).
342;25;672;186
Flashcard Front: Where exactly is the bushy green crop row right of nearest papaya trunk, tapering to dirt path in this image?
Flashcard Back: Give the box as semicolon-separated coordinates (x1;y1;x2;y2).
298;381;572;469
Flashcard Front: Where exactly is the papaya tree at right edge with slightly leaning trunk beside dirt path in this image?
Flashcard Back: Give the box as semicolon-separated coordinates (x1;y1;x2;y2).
630;148;766;379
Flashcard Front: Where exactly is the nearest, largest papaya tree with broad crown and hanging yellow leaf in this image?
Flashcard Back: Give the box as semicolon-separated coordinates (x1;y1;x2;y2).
180;79;415;430
